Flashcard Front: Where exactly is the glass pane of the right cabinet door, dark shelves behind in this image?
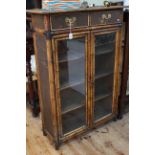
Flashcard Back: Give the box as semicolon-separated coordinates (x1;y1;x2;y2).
94;33;115;121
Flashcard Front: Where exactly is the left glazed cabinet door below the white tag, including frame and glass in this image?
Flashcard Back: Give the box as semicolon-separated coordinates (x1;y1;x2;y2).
54;33;88;137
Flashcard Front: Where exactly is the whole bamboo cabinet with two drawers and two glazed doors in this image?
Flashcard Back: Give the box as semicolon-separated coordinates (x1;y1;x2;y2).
27;6;123;148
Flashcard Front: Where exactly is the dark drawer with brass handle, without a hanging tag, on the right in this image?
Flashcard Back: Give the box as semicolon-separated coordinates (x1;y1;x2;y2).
90;10;123;26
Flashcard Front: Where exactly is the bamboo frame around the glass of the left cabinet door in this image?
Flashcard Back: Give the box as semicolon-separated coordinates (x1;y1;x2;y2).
52;32;90;140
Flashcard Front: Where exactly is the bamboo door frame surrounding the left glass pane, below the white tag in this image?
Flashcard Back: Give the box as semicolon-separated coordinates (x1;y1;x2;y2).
52;31;90;141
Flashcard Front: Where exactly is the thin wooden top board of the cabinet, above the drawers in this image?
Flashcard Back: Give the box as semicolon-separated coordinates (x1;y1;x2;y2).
26;6;124;14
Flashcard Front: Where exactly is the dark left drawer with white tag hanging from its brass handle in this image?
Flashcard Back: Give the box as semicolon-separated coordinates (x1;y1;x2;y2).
51;12;88;29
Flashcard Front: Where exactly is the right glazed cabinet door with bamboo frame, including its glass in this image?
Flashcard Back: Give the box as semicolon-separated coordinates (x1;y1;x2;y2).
92;30;120;124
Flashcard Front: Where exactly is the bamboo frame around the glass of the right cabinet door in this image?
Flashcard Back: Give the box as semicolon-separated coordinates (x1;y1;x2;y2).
91;27;122;127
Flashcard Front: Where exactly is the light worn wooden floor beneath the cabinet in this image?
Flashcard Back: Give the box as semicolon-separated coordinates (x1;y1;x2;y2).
26;108;129;155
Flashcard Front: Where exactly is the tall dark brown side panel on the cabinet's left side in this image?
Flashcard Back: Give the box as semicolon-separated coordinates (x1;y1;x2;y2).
36;33;53;134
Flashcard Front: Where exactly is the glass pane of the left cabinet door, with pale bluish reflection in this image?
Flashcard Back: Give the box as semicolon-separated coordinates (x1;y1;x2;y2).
58;38;86;134
